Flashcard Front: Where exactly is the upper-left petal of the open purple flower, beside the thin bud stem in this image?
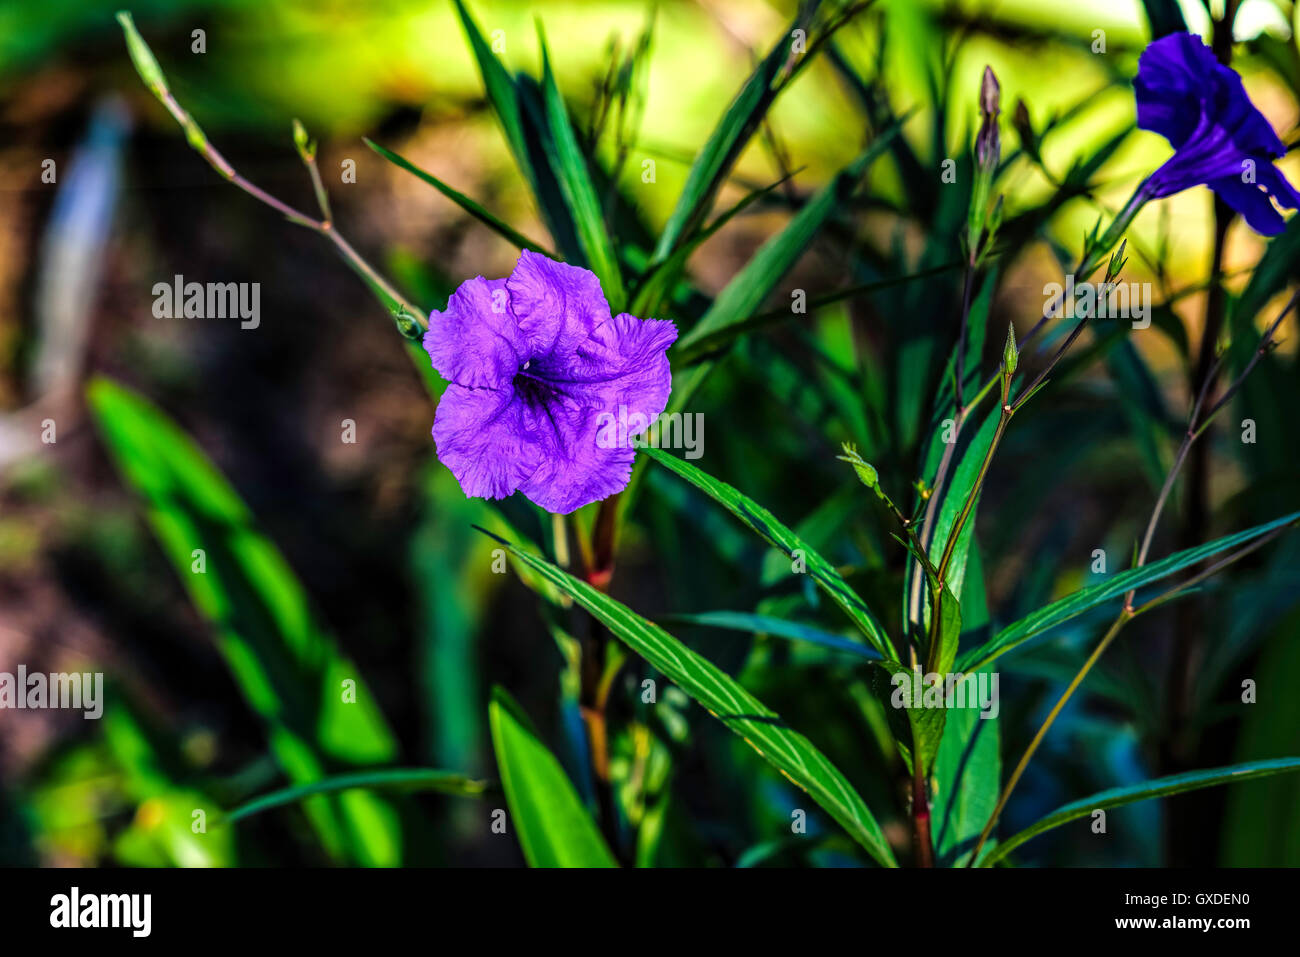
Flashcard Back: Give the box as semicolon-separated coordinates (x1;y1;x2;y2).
424;276;528;389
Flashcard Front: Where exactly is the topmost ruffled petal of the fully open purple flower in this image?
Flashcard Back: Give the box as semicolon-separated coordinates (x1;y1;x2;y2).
506;250;610;359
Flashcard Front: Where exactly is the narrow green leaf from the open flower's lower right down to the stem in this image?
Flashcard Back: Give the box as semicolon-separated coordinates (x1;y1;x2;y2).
641;449;893;658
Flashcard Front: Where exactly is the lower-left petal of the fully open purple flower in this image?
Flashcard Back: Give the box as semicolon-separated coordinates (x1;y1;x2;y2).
433;384;541;498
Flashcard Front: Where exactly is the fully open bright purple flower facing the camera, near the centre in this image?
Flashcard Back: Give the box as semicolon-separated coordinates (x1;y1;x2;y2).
424;250;677;514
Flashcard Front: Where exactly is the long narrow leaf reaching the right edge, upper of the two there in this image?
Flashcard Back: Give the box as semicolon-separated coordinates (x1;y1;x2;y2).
957;512;1300;671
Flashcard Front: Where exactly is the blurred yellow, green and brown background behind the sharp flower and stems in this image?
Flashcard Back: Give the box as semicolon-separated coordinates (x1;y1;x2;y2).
0;0;1300;866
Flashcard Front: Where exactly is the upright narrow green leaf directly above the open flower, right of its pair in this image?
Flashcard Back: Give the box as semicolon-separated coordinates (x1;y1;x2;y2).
538;26;627;313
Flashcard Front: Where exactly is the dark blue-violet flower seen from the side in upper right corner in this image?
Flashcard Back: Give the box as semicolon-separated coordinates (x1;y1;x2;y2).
1134;34;1300;235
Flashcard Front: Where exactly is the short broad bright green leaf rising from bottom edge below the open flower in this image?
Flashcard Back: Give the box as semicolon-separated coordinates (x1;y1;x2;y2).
488;688;618;867
